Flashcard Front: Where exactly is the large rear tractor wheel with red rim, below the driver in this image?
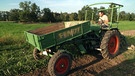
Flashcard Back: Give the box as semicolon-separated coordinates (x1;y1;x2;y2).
100;30;120;59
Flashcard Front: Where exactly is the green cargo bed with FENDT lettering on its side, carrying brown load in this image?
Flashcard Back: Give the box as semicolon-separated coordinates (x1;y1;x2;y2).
25;21;99;50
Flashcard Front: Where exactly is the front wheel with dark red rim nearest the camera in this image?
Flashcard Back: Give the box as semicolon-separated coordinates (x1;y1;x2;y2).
48;51;72;76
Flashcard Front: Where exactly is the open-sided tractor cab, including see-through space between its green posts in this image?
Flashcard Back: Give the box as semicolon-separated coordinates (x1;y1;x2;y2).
85;2;123;29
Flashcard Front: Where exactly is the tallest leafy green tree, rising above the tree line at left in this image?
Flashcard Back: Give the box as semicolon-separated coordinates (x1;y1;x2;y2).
19;1;40;22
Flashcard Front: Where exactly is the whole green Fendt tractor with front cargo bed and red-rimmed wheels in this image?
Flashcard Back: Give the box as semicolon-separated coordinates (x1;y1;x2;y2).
25;3;123;76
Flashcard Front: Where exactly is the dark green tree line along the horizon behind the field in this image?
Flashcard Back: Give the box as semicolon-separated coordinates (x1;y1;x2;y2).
0;1;135;22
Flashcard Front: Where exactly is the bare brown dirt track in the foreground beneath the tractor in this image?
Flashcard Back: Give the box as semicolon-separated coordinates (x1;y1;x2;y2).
22;52;124;76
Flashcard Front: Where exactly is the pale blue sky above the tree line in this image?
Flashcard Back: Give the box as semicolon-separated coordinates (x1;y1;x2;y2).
0;0;135;13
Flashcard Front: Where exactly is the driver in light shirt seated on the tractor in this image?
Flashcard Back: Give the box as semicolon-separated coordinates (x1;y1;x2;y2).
98;11;108;28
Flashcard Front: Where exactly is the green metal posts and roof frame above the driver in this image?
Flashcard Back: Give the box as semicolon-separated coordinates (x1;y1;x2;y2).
85;2;123;27
